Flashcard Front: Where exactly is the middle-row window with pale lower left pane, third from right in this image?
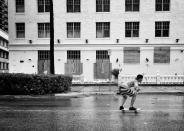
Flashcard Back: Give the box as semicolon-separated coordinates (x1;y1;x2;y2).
96;22;110;38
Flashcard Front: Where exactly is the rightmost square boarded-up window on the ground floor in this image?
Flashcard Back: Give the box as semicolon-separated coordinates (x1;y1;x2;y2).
154;47;170;64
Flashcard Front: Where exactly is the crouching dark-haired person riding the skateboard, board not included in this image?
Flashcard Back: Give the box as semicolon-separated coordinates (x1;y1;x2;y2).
119;74;143;111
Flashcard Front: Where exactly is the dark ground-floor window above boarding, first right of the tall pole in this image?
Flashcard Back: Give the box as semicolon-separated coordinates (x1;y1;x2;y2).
67;50;80;60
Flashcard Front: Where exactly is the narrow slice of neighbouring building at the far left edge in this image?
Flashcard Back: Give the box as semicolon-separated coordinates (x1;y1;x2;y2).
0;0;9;73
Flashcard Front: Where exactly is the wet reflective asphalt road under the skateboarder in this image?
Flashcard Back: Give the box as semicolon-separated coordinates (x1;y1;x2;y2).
0;94;184;131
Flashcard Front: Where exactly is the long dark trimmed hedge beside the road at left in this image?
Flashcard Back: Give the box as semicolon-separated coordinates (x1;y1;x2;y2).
0;73;72;95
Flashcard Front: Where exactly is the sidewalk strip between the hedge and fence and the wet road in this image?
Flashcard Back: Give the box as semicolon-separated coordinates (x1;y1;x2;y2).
0;86;184;100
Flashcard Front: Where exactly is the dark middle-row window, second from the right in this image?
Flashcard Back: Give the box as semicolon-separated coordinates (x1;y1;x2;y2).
125;22;139;37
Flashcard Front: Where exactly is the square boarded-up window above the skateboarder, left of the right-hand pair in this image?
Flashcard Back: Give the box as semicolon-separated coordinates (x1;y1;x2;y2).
124;47;140;64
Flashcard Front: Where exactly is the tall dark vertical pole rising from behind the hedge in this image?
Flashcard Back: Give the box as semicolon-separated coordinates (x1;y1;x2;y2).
50;0;55;74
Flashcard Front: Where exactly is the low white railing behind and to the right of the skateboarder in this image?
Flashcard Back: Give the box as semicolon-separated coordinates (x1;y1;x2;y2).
118;75;184;85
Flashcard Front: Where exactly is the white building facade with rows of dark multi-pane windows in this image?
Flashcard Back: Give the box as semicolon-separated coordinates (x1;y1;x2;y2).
8;0;184;81
